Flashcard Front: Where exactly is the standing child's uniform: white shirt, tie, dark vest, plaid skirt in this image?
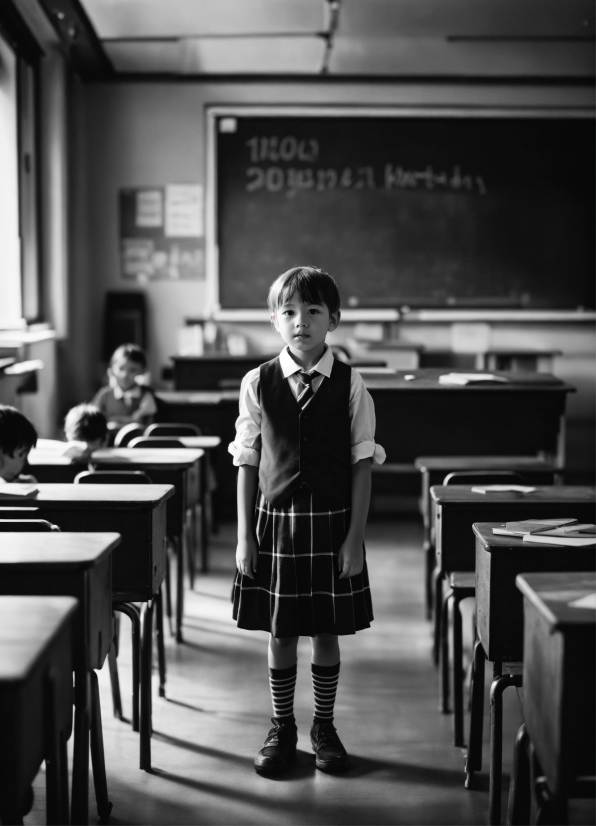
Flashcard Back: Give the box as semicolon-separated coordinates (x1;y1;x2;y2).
229;348;385;637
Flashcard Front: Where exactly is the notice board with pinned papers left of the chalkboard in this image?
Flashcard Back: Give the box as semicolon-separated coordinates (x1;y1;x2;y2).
120;184;205;282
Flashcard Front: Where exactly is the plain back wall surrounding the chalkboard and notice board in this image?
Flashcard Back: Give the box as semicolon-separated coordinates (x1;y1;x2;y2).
66;81;595;476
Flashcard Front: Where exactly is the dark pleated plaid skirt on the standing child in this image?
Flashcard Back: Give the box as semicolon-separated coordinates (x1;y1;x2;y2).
233;487;373;637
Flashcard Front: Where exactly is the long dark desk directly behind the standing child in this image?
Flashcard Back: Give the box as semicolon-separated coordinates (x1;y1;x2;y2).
157;368;574;514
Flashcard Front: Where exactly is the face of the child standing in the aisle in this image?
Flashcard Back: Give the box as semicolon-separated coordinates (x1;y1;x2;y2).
271;295;339;357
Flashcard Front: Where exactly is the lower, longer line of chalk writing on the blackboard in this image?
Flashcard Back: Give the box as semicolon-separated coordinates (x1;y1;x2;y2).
245;164;487;197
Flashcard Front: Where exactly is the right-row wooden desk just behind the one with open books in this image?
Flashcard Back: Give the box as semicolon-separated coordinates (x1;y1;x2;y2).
431;485;596;572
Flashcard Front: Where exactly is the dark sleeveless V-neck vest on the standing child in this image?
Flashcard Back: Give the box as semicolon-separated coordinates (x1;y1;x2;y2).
259;358;352;509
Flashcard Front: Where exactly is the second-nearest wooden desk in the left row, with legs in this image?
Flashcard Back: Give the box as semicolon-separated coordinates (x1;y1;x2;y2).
0;533;120;823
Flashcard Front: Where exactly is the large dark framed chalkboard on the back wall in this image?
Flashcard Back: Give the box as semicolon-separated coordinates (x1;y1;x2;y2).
215;115;595;309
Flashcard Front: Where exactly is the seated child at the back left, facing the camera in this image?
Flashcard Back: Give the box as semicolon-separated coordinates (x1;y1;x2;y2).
91;344;157;430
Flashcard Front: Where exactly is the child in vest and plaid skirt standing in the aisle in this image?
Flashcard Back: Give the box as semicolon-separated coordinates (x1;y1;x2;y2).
230;267;385;773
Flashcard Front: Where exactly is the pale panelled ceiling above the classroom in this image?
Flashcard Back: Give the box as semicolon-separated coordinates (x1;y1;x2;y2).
21;0;595;79
